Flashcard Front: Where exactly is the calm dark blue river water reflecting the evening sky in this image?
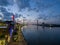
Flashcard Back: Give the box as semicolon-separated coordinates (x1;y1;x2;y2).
22;25;60;45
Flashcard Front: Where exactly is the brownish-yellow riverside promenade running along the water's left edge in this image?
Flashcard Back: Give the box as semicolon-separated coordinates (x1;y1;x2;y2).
8;24;27;45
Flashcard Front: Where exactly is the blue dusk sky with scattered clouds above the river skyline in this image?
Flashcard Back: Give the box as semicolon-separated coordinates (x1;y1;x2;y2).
0;0;60;24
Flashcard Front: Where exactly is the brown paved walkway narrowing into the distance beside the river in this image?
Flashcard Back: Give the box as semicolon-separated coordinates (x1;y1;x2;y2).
8;26;27;45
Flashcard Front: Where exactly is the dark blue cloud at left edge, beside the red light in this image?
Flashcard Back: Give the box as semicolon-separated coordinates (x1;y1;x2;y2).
0;7;13;20
